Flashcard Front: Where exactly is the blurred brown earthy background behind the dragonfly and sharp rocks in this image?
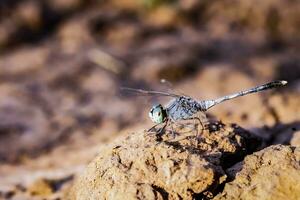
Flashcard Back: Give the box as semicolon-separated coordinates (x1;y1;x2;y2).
0;0;300;199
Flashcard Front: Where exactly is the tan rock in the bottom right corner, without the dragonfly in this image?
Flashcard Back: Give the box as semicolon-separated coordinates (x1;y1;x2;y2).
214;145;300;200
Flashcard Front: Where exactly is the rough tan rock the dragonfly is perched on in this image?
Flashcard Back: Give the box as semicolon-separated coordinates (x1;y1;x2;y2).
68;123;259;199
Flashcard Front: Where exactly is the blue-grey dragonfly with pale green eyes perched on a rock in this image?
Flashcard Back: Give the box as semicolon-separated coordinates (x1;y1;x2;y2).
121;80;288;135
